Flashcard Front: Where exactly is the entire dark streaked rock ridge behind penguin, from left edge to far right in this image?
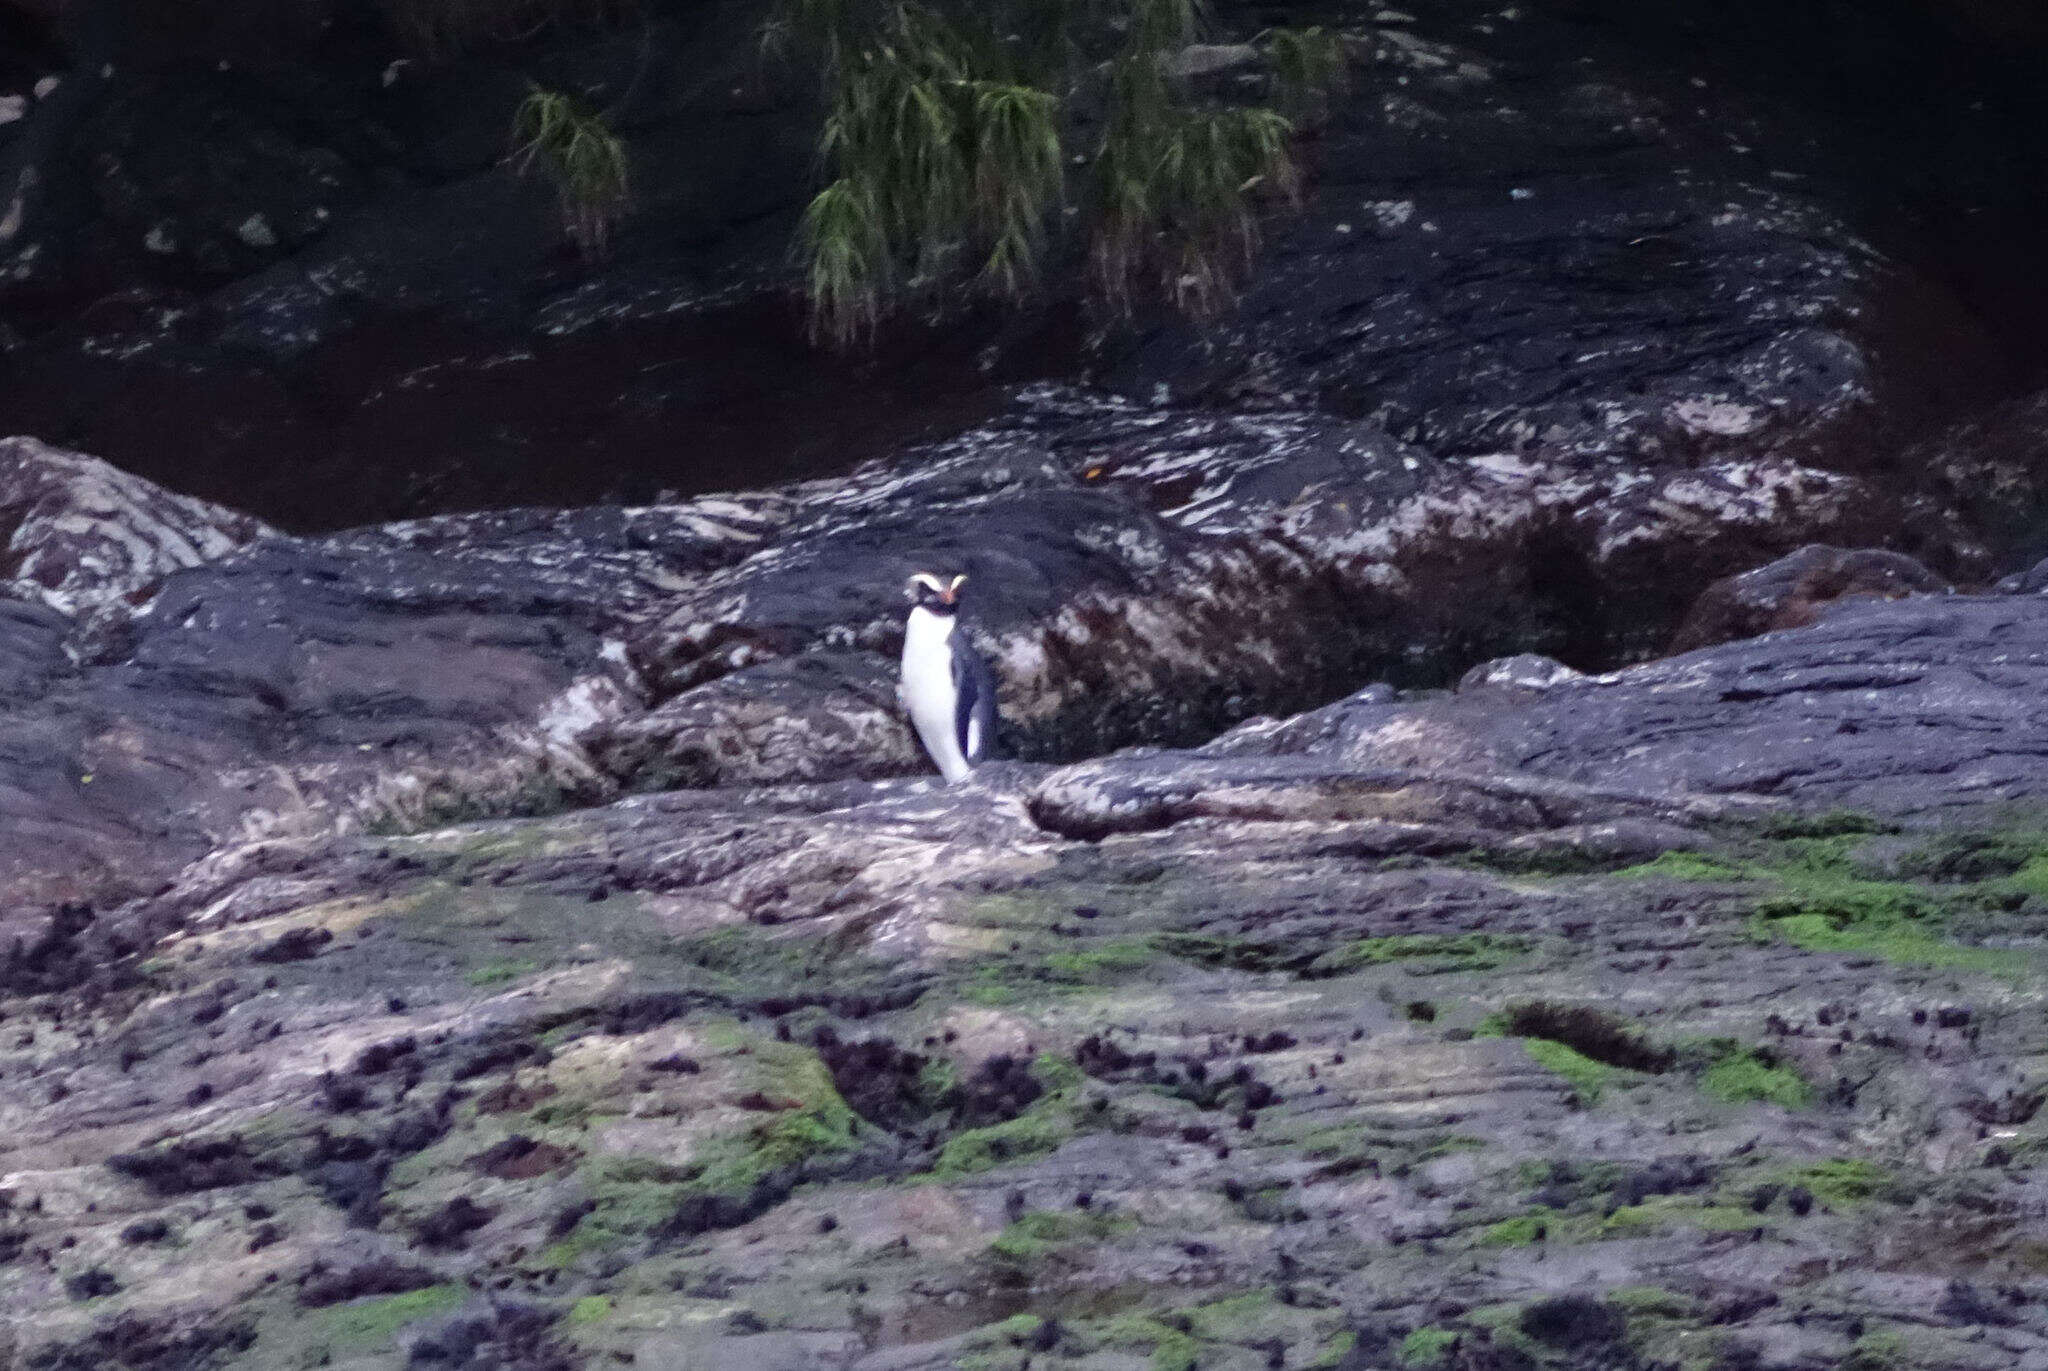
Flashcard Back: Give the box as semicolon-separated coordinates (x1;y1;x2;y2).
0;389;1957;910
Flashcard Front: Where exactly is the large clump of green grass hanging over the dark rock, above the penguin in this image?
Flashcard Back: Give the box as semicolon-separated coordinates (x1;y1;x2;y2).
762;0;1318;346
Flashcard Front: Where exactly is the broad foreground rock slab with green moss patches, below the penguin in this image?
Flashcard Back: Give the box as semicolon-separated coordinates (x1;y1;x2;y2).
0;596;2048;1371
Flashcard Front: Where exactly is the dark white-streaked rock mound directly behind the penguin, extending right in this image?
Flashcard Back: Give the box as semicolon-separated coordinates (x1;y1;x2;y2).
606;389;1908;781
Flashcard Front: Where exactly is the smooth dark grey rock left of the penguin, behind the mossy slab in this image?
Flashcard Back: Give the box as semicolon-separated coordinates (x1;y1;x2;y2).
0;486;782;910
